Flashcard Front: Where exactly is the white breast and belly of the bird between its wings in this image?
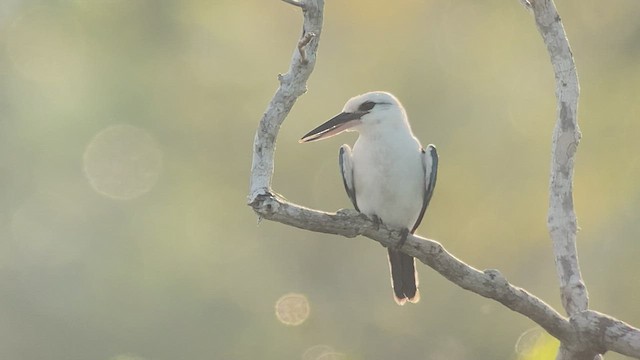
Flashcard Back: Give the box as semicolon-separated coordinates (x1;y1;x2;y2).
353;133;425;229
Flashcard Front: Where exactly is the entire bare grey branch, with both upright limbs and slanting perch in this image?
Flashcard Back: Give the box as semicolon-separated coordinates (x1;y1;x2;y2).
248;0;640;360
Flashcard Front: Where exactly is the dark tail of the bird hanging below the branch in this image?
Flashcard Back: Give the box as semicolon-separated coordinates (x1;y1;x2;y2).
388;248;420;305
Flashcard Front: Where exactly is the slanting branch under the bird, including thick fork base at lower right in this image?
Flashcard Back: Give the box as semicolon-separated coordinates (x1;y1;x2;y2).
249;193;640;360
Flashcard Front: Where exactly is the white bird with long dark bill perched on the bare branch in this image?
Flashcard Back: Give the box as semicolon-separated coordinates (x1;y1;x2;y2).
300;91;438;305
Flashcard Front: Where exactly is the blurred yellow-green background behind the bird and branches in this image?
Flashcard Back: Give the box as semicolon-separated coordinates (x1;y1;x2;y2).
0;0;640;360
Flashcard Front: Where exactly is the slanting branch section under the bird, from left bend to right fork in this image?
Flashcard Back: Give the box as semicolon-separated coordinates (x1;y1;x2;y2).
249;194;573;339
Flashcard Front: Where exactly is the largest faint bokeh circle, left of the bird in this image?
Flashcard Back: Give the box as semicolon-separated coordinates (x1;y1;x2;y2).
83;125;162;200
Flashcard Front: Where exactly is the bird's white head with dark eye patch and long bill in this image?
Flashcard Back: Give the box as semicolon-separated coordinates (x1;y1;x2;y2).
300;91;408;143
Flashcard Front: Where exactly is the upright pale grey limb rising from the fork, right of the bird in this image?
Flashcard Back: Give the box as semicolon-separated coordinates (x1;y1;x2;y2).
528;0;601;360
